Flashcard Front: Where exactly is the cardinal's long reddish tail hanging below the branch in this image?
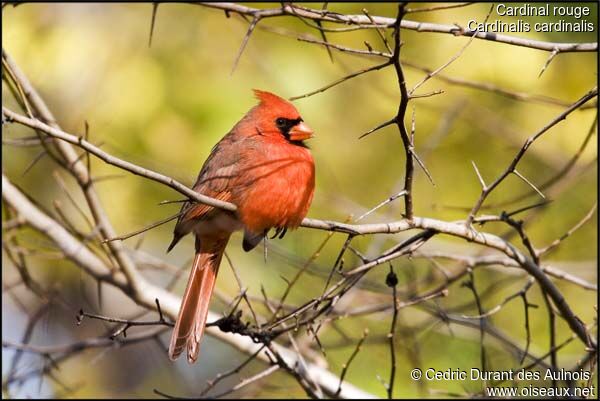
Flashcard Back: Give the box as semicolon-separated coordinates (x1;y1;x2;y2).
169;236;229;363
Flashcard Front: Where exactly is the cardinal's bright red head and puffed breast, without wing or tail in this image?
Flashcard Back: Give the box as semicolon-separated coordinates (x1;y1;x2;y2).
232;91;315;233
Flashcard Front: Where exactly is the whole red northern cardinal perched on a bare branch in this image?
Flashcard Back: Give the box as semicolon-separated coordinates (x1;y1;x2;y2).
167;89;315;363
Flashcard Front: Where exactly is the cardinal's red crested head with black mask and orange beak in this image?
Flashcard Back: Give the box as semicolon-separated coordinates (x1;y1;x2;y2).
253;89;313;144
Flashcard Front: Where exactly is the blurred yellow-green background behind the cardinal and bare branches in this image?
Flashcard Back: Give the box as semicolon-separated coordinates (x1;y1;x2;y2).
2;3;598;398
